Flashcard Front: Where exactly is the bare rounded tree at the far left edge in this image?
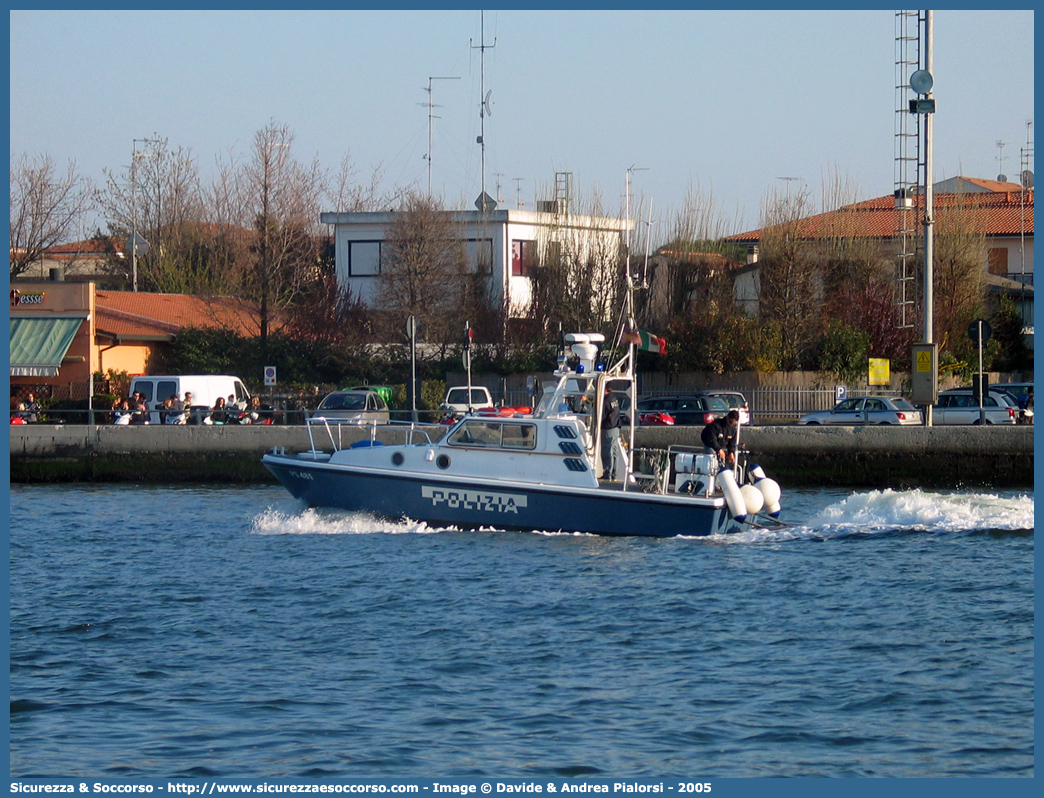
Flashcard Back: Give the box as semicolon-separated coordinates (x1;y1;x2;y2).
10;154;93;277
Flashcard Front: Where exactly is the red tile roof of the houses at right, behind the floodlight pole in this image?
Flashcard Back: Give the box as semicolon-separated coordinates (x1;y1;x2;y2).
725;189;1034;242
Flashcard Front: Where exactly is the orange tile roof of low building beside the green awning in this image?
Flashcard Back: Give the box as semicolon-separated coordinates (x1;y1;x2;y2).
95;290;258;338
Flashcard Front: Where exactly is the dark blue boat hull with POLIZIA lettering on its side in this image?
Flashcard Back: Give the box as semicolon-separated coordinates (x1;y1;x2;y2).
262;454;741;537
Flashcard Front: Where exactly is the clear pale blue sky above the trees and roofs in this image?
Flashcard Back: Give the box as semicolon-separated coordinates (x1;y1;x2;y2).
10;10;1034;237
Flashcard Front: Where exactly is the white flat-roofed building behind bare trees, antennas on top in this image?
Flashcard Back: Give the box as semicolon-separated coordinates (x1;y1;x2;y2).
319;209;631;318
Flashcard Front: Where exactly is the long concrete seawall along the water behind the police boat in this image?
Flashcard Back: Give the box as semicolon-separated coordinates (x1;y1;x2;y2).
10;424;1034;488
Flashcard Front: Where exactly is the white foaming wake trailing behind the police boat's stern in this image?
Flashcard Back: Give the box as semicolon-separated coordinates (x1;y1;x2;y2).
716;489;1034;542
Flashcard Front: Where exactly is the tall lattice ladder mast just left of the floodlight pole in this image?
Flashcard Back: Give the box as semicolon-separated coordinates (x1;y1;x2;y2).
895;11;923;327
